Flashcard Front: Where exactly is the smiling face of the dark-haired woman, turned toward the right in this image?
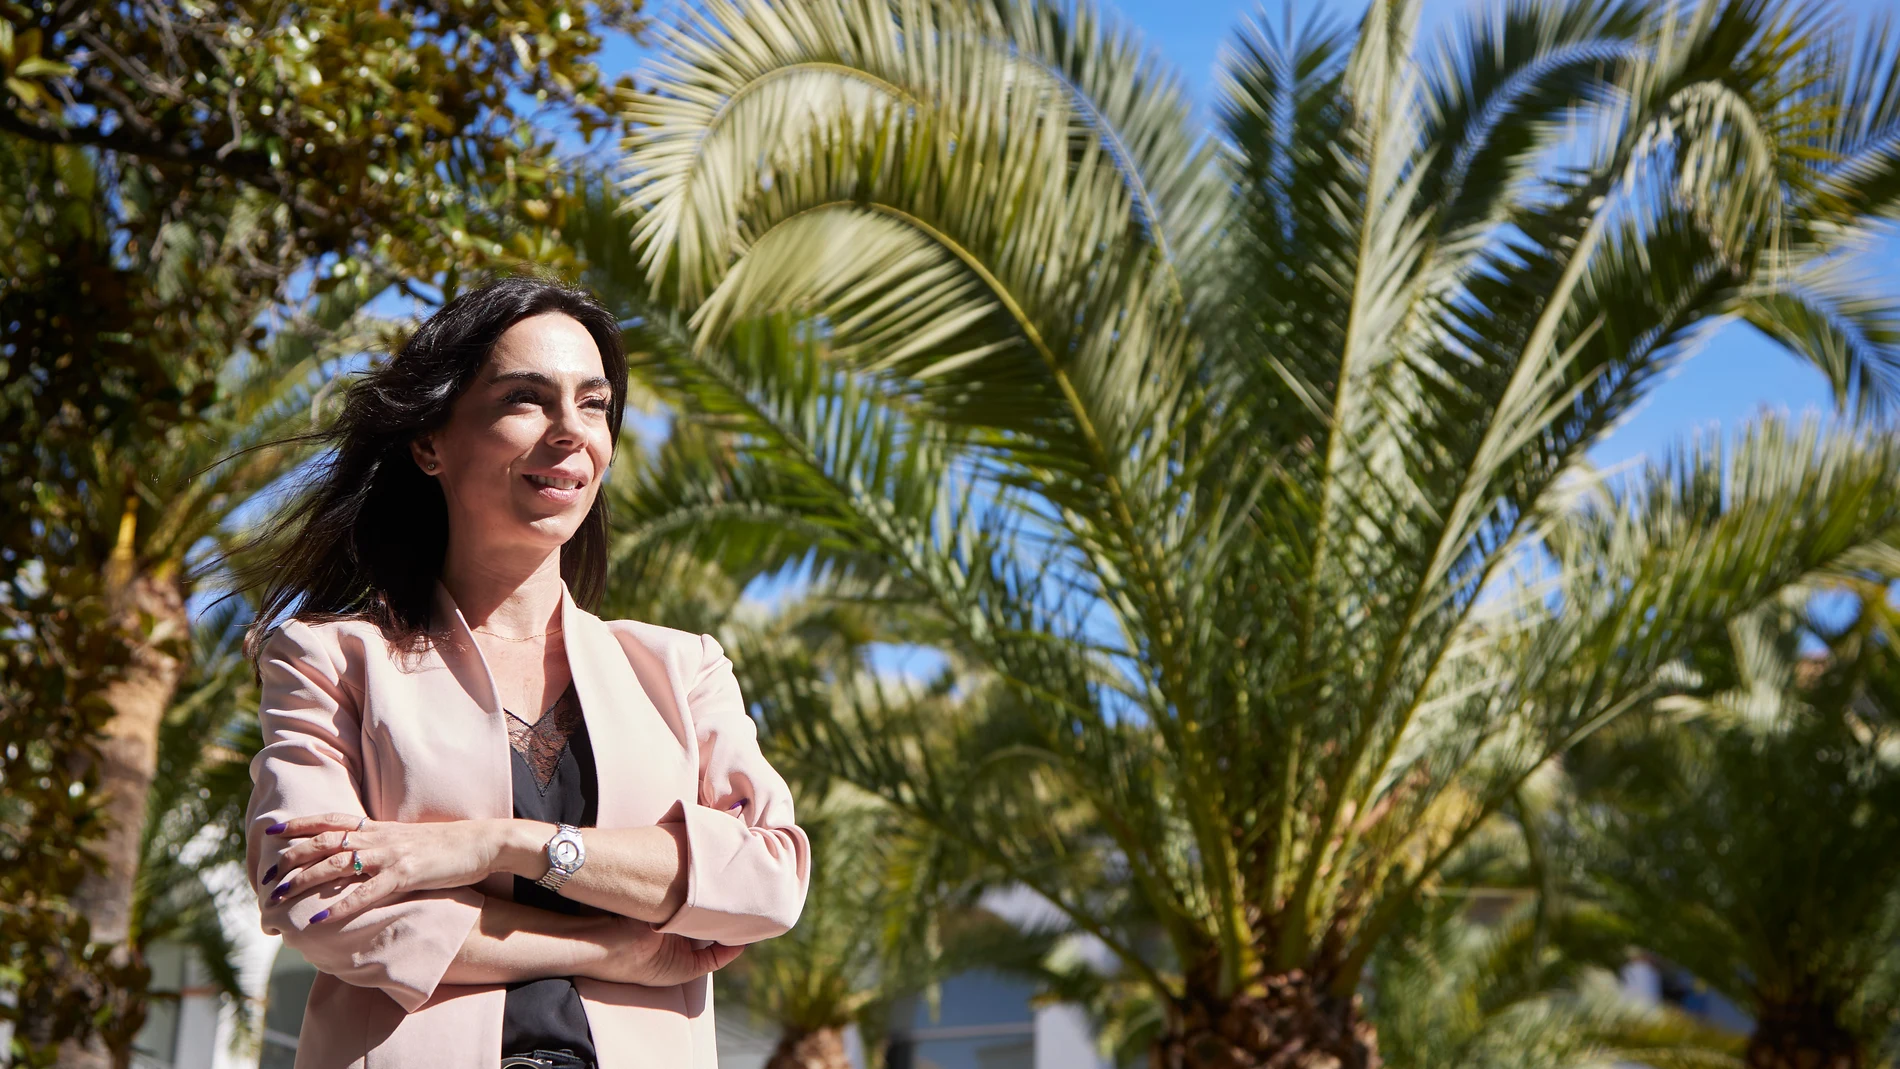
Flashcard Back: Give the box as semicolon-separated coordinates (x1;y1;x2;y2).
410;311;614;553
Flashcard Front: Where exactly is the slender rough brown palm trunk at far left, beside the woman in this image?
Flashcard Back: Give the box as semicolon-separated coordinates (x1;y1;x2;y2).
59;575;190;1069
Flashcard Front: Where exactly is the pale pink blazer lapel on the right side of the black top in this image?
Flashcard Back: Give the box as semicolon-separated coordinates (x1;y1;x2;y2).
561;589;697;828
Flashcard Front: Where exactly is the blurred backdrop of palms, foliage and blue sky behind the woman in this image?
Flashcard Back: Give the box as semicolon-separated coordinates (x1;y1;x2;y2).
0;0;1900;1069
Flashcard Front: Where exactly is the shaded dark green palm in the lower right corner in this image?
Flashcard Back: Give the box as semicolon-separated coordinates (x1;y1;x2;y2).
1579;585;1900;1069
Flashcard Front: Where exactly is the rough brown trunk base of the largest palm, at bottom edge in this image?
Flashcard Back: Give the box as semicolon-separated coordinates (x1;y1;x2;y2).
1150;970;1383;1069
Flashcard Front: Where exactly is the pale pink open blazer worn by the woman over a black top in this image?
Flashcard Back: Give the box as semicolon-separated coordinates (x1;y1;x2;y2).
245;585;811;1069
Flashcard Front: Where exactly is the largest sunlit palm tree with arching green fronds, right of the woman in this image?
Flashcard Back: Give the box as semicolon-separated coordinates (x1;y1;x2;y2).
600;0;1900;1069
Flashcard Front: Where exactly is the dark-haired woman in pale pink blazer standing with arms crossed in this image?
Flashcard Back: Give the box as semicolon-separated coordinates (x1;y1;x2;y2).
247;277;809;1069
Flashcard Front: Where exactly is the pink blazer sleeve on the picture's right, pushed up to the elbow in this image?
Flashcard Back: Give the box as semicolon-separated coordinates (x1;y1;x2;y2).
659;636;811;946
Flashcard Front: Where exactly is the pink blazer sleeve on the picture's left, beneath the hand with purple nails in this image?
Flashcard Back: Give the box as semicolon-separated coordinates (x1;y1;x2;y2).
245;621;485;1012
